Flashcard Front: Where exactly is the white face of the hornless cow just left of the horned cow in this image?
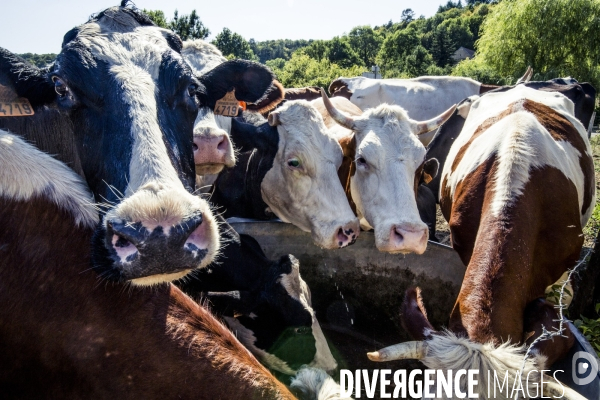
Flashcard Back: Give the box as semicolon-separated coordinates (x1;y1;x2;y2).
261;100;359;249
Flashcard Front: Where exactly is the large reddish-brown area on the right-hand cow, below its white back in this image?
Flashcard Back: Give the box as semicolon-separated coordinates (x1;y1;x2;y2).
449;162;583;350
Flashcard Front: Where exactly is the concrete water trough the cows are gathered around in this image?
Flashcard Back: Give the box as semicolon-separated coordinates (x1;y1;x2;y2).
228;218;600;398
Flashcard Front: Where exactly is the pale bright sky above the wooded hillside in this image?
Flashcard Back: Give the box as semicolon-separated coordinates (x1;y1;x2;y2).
0;0;447;53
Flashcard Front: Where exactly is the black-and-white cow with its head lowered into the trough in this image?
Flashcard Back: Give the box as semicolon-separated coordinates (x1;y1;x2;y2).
177;230;337;379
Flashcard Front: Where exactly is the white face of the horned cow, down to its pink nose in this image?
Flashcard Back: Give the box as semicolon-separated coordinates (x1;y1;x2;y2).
350;104;428;254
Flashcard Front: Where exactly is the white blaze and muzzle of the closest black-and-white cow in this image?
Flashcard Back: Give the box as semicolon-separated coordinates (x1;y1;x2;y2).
70;24;219;285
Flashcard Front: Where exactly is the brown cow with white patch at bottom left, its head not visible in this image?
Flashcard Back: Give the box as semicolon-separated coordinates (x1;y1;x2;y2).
0;130;350;400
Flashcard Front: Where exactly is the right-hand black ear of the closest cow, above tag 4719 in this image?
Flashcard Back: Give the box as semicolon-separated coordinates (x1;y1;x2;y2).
198;60;283;108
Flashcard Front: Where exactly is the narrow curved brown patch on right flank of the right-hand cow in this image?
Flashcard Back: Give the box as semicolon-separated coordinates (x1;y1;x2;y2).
523;99;595;214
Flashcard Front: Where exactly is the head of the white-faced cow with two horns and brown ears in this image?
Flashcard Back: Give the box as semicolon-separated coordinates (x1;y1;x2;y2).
313;91;455;254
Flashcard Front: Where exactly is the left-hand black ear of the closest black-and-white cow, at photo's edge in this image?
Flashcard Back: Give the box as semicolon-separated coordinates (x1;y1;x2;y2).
0;48;56;107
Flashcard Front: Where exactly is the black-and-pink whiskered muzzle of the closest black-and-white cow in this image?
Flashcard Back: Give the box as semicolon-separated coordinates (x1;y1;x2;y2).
93;190;220;286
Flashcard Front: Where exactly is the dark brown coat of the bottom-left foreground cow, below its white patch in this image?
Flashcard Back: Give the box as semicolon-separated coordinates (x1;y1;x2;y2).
0;194;293;399
